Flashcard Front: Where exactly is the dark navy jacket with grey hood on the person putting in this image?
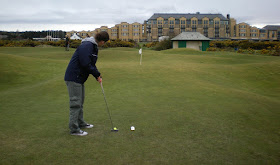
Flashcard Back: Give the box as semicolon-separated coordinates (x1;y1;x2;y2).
64;38;100;84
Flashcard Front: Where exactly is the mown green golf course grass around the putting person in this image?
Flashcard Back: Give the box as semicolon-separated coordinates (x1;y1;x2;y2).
0;48;280;164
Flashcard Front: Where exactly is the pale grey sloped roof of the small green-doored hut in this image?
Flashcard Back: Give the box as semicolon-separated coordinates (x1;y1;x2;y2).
171;32;211;41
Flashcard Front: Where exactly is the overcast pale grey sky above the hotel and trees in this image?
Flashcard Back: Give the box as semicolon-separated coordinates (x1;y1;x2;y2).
0;0;280;30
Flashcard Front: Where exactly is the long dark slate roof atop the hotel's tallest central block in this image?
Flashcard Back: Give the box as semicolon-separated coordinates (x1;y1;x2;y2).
149;12;228;20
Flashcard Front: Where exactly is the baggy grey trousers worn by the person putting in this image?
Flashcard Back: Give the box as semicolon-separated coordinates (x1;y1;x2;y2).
65;81;87;133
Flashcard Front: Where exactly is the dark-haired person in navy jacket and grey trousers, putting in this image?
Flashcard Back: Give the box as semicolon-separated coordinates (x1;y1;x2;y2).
64;31;109;136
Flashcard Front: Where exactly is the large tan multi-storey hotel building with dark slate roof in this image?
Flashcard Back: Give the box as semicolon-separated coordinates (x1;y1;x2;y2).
67;12;280;42
